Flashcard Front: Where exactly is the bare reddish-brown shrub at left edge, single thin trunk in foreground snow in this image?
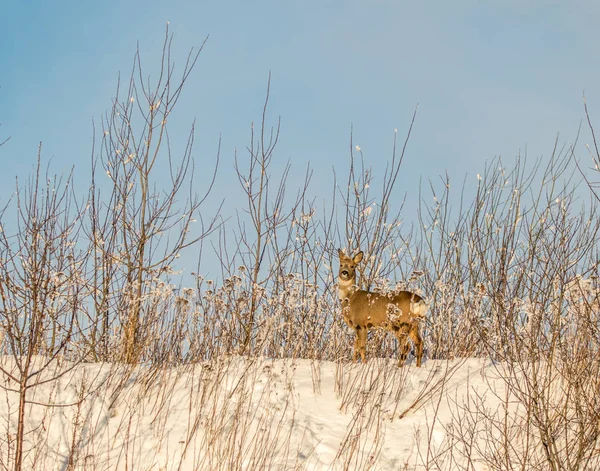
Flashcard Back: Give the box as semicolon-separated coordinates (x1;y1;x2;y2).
0;150;87;470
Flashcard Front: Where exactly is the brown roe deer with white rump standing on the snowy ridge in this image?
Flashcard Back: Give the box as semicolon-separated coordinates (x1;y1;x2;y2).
338;249;427;367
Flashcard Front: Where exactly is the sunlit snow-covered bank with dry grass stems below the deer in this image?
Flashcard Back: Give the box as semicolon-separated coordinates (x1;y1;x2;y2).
0;356;504;471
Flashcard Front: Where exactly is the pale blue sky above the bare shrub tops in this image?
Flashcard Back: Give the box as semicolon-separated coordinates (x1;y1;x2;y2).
0;0;600;272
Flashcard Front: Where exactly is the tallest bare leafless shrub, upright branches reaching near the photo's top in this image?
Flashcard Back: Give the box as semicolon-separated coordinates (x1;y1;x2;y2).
83;28;218;363
